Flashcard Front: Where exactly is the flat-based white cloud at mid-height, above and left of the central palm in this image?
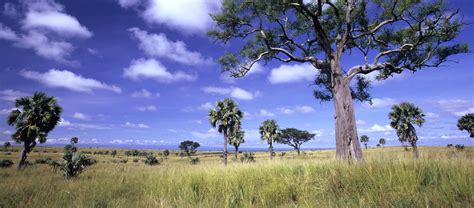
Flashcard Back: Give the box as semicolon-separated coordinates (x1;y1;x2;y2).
123;59;197;83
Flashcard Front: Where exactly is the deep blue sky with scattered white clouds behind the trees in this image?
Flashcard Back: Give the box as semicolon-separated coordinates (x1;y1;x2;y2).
0;0;474;149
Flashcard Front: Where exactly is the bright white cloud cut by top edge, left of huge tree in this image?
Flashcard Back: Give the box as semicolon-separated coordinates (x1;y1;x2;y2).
142;0;221;33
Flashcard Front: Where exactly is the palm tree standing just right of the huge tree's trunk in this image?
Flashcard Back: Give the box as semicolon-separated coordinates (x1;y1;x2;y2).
388;102;425;158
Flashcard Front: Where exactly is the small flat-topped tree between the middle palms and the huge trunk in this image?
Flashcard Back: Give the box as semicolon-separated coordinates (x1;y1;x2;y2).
276;128;315;155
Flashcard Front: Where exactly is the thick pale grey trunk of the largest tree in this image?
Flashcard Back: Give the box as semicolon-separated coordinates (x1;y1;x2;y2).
331;61;363;160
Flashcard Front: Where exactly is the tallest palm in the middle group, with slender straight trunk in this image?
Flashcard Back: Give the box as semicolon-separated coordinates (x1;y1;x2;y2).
208;98;243;165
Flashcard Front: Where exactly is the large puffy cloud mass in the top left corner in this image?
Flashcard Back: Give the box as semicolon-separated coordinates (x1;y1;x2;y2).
0;0;92;64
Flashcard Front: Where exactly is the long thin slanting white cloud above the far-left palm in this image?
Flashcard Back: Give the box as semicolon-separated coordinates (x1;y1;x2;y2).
20;69;122;93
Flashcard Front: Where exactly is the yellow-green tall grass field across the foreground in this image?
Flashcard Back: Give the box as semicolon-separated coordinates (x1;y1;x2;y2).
0;147;474;207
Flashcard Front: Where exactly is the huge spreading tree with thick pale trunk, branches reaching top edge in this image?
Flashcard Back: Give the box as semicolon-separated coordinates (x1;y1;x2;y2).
209;0;468;160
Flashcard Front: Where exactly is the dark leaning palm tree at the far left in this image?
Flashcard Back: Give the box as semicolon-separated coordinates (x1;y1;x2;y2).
7;92;62;169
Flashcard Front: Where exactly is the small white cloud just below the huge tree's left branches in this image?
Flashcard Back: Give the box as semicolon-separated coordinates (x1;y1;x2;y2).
268;63;318;84
